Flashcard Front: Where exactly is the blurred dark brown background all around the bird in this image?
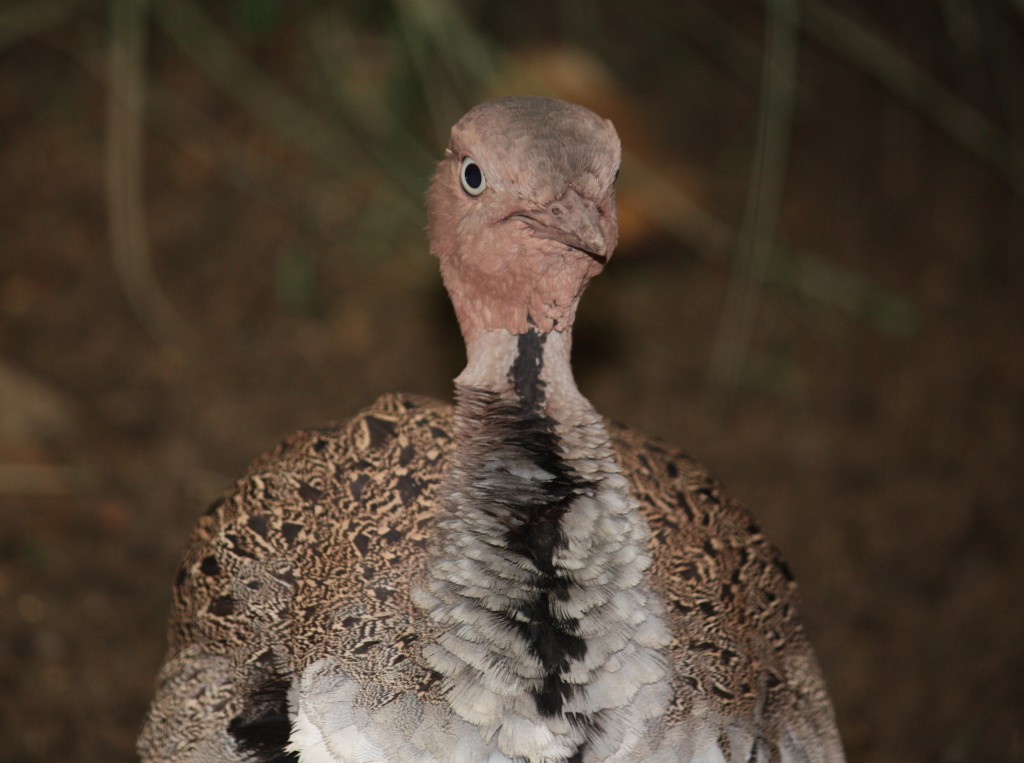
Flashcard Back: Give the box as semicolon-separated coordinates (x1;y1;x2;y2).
0;0;1024;763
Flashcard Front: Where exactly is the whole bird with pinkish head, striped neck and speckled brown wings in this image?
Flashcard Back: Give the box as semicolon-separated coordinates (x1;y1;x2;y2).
138;96;844;763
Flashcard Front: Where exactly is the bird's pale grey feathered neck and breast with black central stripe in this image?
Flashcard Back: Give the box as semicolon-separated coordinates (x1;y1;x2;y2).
417;325;668;761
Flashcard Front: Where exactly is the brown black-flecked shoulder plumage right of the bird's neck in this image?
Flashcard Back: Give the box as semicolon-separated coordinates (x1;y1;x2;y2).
609;424;838;759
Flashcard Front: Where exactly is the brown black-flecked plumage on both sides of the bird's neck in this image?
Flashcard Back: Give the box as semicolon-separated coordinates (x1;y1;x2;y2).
144;395;837;760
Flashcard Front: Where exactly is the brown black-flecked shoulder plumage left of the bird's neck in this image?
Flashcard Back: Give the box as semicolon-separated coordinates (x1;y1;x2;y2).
170;394;452;670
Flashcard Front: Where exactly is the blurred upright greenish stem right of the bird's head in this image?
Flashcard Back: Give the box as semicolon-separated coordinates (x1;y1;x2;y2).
709;0;800;401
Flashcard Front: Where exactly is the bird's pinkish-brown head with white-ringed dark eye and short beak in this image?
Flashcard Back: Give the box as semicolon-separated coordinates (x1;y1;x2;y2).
427;97;622;339
